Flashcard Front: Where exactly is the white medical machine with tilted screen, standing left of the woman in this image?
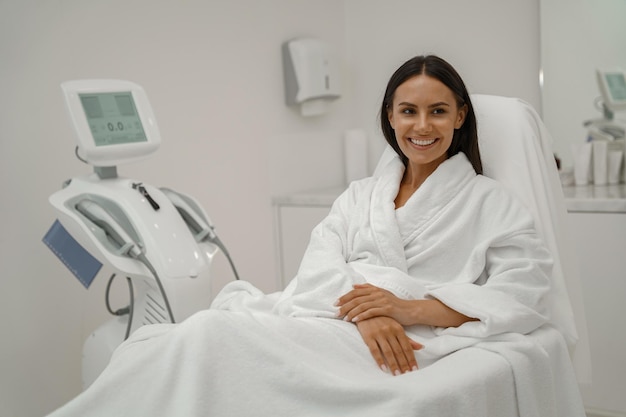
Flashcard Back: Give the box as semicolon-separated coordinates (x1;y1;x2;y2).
44;80;238;388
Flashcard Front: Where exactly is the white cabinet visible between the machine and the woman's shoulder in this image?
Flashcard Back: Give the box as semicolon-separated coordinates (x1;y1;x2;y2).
273;187;343;288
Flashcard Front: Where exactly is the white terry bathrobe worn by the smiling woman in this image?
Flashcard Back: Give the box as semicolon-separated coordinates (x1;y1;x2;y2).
213;153;552;356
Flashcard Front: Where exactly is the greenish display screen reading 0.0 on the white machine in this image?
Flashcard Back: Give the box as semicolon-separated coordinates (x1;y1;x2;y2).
78;92;148;146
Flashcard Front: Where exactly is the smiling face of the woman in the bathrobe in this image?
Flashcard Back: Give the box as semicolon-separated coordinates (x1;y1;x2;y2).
387;75;467;172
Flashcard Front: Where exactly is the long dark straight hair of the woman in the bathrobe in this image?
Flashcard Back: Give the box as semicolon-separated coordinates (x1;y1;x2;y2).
380;55;483;174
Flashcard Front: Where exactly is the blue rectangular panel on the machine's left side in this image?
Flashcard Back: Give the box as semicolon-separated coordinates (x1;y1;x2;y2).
43;220;102;288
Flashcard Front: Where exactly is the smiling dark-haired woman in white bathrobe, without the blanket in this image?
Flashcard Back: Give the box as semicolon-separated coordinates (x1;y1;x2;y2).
266;56;552;375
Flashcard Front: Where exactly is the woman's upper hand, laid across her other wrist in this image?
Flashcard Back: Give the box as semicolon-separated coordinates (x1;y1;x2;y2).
336;284;415;326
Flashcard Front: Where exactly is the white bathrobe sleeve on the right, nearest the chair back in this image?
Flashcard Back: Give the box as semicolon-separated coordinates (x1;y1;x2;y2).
426;180;553;338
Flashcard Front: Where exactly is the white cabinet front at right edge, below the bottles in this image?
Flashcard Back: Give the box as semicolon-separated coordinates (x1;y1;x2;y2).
568;212;626;415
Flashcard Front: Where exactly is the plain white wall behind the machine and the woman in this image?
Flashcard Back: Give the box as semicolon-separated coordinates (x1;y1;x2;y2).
0;0;539;417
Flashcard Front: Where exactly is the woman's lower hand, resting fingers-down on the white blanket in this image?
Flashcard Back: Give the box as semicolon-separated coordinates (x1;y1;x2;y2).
356;317;423;375
